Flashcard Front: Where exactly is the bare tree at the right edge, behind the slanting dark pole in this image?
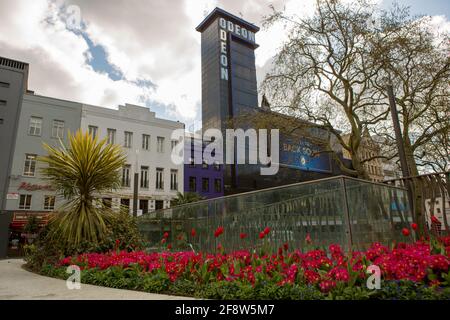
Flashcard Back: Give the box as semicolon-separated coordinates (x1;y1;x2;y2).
374;7;450;176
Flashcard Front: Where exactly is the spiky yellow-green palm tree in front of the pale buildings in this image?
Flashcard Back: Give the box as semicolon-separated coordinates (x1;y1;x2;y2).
39;130;126;248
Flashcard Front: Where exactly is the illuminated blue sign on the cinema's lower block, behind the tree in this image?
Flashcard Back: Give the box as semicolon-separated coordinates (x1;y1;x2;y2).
280;138;331;172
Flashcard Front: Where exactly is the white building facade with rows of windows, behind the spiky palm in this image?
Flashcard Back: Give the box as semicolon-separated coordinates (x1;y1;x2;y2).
81;104;184;215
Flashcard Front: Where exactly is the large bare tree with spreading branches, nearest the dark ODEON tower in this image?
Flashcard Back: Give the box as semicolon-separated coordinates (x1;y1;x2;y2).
262;0;388;178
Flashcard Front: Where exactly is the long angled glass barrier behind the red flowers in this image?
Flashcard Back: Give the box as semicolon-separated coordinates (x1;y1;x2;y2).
138;176;411;252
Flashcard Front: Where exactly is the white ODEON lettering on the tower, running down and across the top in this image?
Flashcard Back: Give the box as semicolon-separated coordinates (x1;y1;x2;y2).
219;18;255;81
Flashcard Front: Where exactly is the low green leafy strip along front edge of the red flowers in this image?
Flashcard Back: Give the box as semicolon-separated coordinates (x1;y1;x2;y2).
36;264;450;300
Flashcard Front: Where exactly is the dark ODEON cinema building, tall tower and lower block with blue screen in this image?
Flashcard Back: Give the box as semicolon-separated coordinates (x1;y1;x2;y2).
195;8;342;195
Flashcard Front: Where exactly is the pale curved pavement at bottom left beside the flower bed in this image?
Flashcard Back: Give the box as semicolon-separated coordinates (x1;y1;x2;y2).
0;259;193;300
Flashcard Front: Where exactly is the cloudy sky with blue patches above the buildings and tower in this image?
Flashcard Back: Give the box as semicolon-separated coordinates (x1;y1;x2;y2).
0;0;450;129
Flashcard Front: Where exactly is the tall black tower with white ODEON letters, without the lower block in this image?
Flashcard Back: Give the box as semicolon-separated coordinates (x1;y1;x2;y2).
196;8;259;193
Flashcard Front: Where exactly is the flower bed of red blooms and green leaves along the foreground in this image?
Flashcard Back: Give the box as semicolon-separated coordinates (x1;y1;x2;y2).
38;237;450;299
